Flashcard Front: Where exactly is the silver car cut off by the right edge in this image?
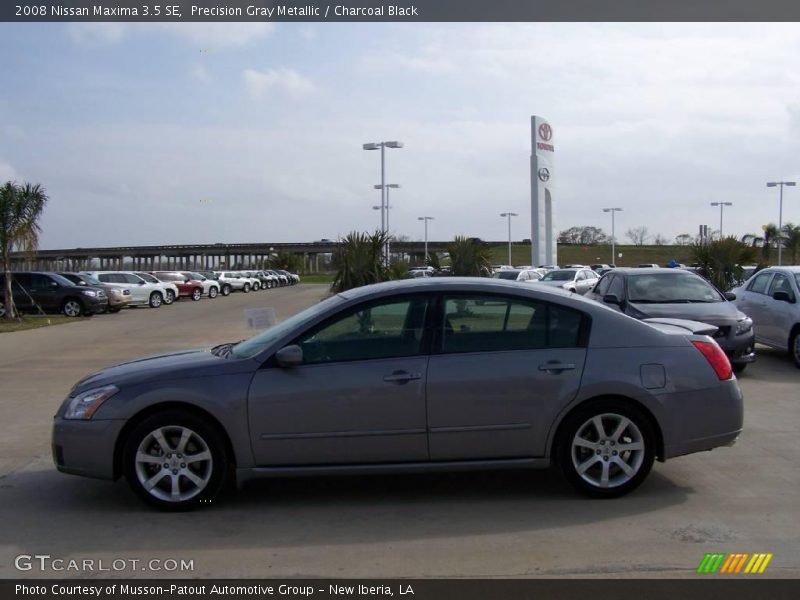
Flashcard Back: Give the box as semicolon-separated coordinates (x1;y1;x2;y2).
732;267;800;368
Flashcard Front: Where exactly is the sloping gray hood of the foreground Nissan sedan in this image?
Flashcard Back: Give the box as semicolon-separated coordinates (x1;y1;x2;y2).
69;348;257;396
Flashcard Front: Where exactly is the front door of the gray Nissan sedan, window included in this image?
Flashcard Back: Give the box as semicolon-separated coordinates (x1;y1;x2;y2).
248;295;429;466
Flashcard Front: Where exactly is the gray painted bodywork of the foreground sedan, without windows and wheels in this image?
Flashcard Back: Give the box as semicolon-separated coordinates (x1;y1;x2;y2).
53;278;743;482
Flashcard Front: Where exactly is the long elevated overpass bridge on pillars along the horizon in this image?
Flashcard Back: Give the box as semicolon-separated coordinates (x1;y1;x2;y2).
11;240;508;273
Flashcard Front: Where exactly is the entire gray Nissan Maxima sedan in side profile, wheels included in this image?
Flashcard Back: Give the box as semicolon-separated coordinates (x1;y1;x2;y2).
53;278;742;509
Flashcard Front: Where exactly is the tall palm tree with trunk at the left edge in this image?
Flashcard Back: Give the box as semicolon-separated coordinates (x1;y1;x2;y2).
0;181;48;319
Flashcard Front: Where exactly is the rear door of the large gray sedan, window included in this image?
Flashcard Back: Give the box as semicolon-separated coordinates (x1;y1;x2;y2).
428;294;588;461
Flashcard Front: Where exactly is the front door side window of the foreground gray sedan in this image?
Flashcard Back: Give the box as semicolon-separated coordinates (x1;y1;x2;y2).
295;297;428;364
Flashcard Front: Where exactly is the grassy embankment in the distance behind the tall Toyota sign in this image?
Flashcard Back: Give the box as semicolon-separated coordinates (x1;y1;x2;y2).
491;244;692;267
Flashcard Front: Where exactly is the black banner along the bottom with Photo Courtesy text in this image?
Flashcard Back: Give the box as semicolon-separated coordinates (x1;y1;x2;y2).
0;576;800;600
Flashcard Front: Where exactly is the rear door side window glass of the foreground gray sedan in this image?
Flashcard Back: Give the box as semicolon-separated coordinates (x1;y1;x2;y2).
439;296;581;354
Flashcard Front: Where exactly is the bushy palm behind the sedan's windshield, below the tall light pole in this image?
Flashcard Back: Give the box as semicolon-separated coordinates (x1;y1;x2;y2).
331;231;391;293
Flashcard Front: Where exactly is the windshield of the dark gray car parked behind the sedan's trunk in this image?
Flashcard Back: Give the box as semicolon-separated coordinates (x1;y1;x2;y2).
628;273;725;304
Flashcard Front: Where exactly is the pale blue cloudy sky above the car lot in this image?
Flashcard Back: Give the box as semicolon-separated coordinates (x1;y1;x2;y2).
0;23;800;248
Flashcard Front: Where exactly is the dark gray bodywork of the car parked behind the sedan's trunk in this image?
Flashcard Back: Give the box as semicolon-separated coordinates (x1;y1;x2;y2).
586;267;755;364
